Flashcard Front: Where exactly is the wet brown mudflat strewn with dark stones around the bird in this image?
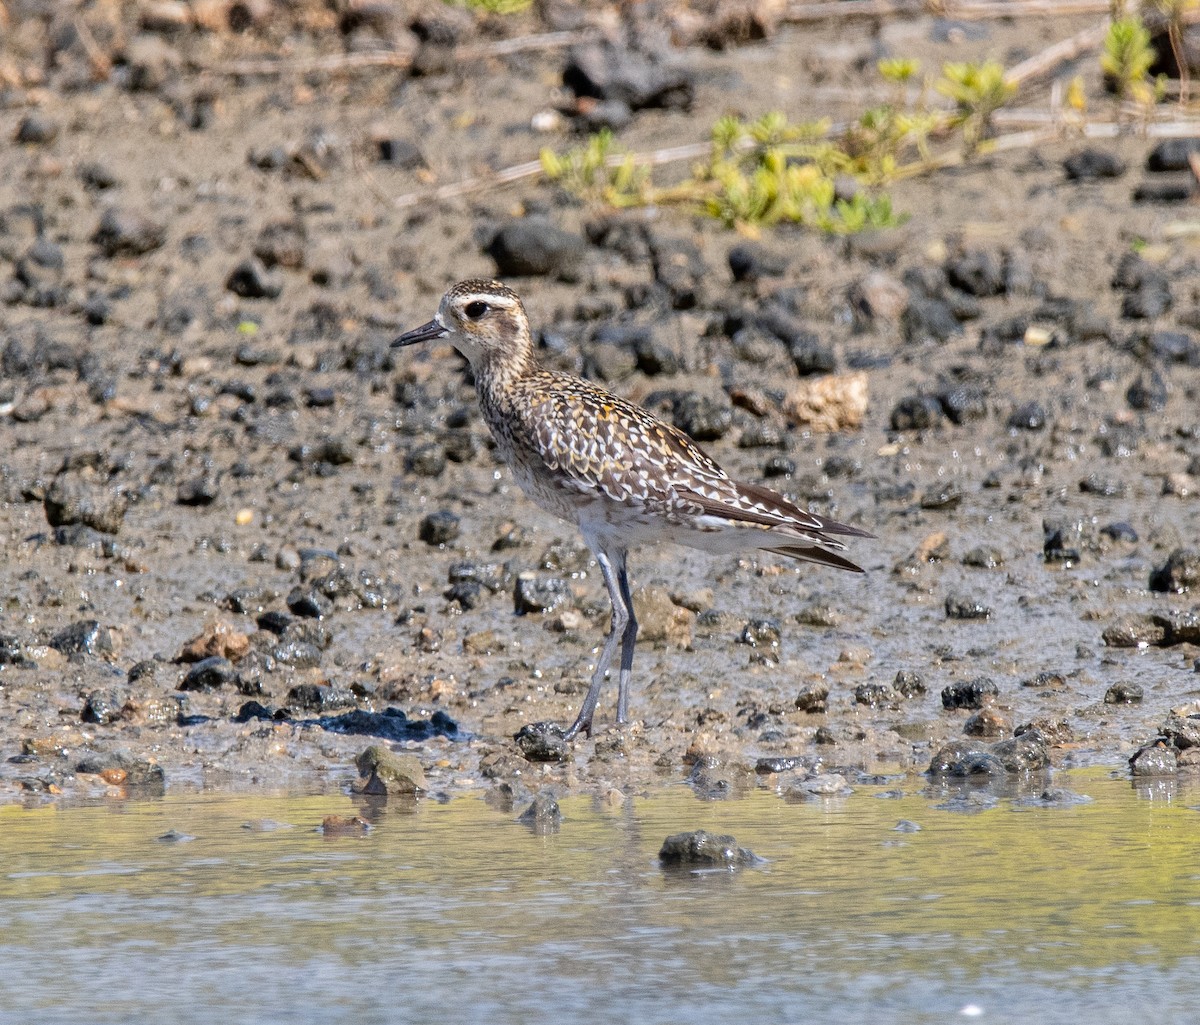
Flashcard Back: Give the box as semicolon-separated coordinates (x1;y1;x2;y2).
0;4;1200;801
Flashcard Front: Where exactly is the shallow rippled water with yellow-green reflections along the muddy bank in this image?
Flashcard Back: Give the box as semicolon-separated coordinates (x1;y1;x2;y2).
0;771;1200;1025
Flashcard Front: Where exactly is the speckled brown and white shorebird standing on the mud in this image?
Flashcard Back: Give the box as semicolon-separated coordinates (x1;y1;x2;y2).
392;280;874;739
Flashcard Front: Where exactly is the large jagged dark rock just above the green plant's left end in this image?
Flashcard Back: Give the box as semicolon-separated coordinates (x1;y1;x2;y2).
563;41;695;110
